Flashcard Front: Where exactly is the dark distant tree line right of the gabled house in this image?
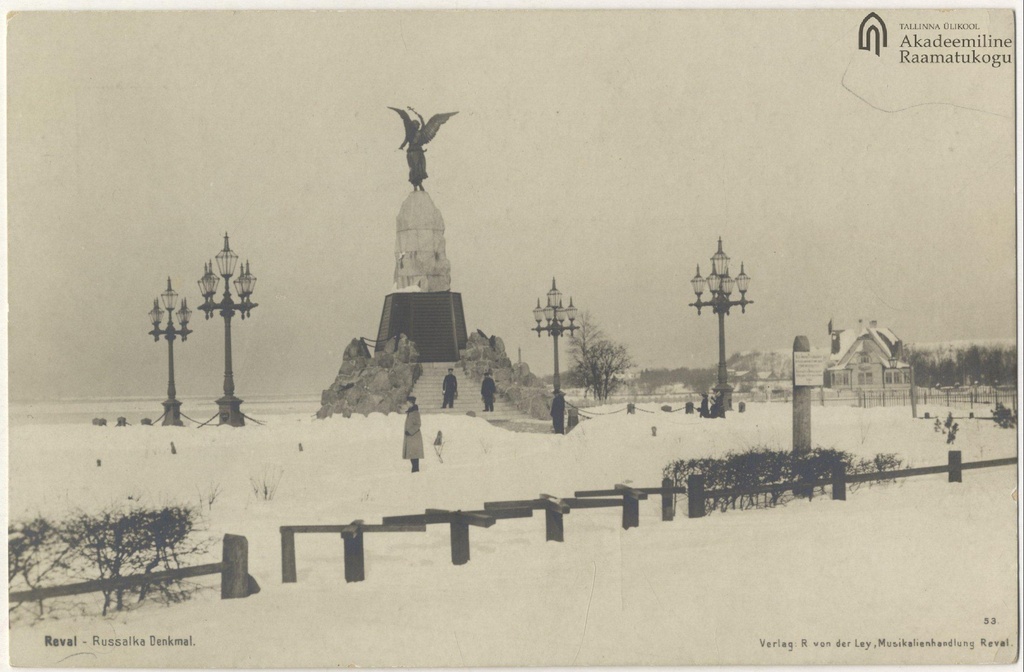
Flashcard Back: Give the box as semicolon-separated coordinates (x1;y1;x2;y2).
905;344;1017;387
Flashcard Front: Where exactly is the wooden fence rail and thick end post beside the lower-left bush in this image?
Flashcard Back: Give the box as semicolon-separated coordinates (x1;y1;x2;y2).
7;535;259;602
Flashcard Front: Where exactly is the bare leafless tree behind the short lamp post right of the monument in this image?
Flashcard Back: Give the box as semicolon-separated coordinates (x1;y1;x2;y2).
567;310;633;400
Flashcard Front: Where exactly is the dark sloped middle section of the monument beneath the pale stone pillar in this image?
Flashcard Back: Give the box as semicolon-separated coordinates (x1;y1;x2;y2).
375;292;467;362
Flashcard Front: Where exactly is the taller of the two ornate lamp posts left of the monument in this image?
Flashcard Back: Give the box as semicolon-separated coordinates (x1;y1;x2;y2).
199;234;259;427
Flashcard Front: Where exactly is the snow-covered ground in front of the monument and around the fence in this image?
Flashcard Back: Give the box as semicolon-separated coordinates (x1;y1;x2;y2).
9;404;1018;667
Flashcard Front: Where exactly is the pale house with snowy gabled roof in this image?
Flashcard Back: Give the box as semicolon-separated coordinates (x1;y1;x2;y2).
824;320;910;390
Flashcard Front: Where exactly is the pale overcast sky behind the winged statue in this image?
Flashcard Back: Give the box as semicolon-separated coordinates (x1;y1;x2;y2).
8;10;1016;400
